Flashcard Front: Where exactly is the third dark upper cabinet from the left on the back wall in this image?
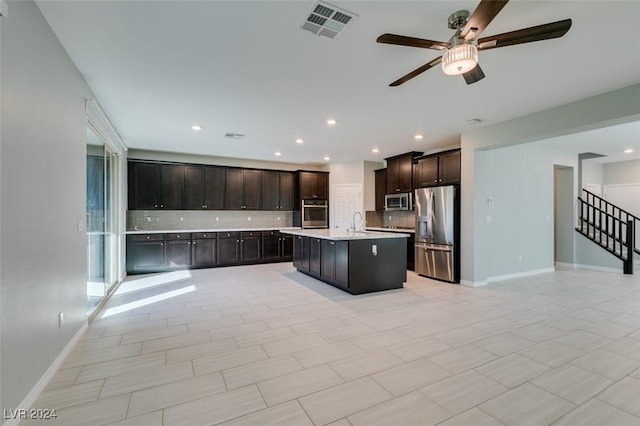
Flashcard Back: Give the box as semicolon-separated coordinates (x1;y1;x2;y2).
224;169;262;210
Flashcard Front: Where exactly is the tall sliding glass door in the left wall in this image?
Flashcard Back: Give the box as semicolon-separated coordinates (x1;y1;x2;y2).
87;126;117;314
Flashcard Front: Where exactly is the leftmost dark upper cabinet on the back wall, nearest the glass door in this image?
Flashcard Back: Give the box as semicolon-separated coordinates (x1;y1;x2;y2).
128;161;184;210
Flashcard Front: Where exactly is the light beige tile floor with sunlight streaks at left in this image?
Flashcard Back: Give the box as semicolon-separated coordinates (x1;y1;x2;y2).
22;263;640;426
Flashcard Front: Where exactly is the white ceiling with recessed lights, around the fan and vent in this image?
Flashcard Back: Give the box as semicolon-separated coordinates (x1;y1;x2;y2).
37;0;640;164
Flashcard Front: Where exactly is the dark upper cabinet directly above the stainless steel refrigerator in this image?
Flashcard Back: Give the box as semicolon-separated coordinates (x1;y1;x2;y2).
414;149;460;188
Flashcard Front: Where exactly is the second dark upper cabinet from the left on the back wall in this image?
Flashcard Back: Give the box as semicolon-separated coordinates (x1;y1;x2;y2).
183;164;226;210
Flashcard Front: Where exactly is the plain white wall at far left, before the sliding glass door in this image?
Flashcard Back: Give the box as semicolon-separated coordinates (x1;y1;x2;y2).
0;0;92;409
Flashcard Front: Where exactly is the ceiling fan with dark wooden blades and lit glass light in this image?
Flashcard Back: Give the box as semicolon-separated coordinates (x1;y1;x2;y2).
376;0;571;86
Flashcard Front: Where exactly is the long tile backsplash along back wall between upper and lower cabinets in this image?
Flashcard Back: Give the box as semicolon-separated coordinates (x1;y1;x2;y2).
127;210;293;231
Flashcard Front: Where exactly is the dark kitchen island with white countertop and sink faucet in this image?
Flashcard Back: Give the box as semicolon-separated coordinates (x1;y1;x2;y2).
280;229;410;294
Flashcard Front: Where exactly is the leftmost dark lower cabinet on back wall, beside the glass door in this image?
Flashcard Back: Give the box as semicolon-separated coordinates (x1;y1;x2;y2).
127;234;164;273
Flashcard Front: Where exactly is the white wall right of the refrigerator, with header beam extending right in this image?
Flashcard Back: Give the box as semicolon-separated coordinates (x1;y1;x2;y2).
461;85;640;285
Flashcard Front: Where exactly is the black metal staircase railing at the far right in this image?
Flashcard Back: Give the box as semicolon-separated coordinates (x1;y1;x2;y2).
576;189;640;274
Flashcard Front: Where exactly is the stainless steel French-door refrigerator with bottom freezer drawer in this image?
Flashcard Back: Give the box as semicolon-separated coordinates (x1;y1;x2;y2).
415;185;460;283
